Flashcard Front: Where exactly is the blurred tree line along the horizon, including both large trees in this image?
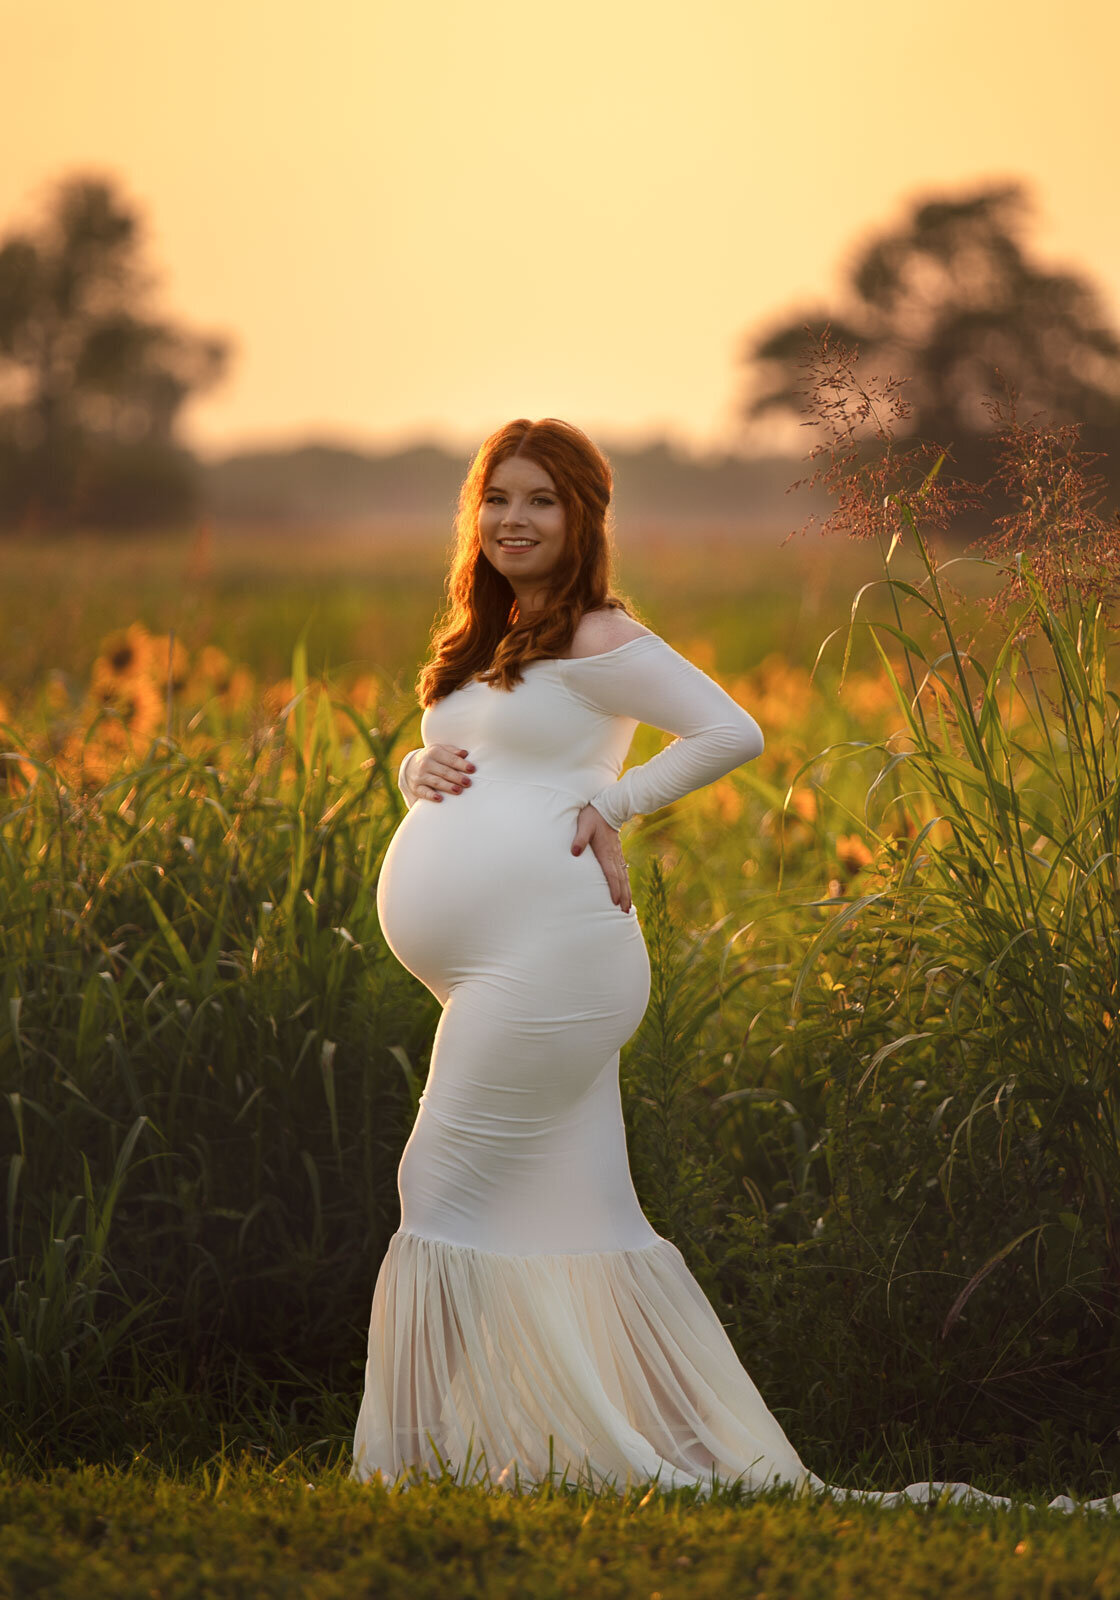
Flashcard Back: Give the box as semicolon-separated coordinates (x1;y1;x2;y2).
0;174;1120;536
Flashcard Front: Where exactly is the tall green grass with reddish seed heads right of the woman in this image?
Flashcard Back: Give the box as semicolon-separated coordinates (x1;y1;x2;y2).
620;366;1120;1491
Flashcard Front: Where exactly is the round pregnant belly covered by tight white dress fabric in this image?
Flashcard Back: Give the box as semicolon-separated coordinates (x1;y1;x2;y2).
378;774;650;1026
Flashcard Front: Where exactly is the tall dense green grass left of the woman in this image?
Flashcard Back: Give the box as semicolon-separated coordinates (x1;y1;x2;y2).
0;650;435;1450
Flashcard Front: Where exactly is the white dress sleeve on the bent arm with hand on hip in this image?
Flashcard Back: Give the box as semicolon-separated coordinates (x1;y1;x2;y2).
562;634;765;827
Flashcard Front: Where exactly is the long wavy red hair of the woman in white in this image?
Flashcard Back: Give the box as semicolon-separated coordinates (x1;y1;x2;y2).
416;416;635;706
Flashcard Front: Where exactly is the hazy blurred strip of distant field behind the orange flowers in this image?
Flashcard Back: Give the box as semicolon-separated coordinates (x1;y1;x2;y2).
0;525;976;699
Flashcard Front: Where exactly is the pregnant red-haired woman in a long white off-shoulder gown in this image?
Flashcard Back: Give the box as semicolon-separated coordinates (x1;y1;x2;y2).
350;419;1113;1504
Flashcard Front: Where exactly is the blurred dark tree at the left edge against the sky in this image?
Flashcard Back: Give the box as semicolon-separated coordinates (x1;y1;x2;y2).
0;176;230;530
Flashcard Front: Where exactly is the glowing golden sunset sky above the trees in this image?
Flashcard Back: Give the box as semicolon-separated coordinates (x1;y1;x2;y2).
0;0;1120;453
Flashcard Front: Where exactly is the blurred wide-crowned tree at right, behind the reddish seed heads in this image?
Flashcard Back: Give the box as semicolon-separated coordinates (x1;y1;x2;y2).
741;182;1120;524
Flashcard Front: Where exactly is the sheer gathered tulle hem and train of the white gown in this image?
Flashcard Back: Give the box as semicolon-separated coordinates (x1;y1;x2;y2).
350;1229;1120;1510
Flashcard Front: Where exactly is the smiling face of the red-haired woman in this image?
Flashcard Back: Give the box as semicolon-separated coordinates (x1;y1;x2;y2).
478;456;566;611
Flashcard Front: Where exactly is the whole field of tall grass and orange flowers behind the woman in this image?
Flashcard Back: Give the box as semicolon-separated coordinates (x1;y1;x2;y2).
0;512;1120;1523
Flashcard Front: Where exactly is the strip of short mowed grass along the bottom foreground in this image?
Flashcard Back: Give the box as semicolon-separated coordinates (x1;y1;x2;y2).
0;1458;1120;1600
